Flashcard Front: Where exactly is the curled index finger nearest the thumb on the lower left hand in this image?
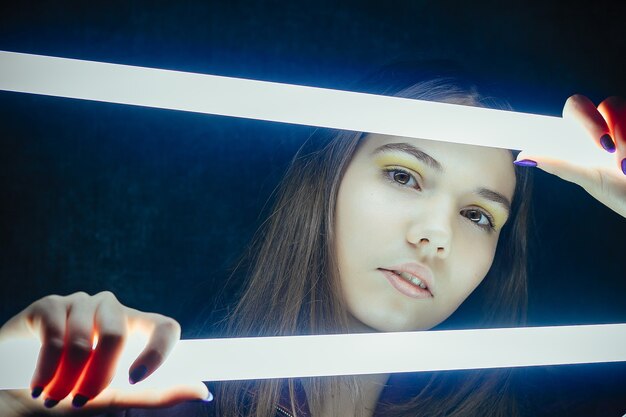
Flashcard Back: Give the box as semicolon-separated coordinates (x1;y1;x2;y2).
128;313;180;384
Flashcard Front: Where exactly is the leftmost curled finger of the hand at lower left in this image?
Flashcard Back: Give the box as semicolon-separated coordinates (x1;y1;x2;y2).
27;296;67;398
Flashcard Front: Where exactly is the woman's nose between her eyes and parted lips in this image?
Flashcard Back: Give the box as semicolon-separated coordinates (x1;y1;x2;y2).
406;200;452;259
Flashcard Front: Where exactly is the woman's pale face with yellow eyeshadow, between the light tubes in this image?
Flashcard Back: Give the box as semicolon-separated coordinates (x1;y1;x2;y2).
336;135;515;331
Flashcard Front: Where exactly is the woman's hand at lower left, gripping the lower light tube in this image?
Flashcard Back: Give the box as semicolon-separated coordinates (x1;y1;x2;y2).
0;291;210;416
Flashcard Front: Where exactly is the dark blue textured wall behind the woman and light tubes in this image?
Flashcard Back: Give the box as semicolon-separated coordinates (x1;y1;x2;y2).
0;1;626;411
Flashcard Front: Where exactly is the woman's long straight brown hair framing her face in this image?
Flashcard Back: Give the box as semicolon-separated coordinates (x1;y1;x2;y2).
216;63;530;417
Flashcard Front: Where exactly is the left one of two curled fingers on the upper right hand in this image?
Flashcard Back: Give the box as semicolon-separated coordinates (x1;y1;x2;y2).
563;94;615;153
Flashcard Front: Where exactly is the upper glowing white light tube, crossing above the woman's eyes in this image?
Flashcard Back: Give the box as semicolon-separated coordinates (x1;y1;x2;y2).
0;51;611;165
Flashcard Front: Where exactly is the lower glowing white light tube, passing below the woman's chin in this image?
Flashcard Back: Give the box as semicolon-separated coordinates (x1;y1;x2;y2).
0;324;626;389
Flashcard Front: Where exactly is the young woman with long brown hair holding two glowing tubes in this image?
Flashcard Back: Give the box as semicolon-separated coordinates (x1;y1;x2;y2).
0;69;626;417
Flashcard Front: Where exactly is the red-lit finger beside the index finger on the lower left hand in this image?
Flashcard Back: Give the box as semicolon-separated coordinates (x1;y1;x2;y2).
72;292;128;407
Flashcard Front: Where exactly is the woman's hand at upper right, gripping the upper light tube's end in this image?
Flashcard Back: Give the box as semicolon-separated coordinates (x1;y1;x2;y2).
516;95;626;217
